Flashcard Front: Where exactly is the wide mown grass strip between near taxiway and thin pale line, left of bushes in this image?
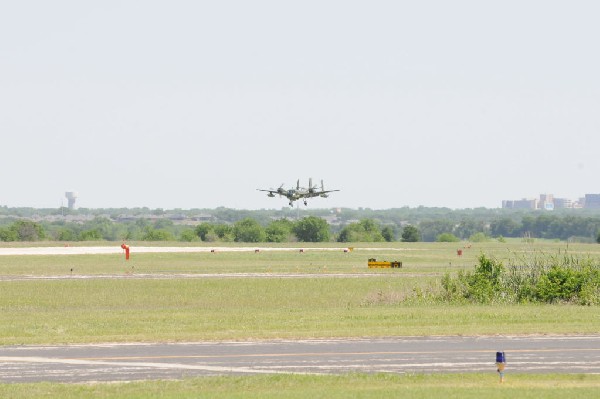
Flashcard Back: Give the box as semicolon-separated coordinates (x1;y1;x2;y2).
0;277;600;345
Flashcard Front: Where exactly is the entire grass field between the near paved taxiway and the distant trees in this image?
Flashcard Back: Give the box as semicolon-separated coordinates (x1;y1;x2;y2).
0;242;600;345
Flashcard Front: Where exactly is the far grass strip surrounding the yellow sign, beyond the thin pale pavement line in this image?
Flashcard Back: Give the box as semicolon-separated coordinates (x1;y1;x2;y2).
0;240;600;275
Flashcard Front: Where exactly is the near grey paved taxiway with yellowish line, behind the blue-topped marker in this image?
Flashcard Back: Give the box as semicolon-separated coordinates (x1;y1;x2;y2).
0;335;600;382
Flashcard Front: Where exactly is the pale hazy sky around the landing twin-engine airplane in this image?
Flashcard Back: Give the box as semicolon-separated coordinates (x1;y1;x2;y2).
0;0;600;209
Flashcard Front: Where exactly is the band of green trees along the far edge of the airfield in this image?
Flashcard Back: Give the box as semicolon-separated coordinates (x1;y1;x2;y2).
0;211;600;242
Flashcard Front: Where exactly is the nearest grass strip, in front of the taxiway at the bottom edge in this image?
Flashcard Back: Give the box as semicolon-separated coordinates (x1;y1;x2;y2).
0;373;600;399
